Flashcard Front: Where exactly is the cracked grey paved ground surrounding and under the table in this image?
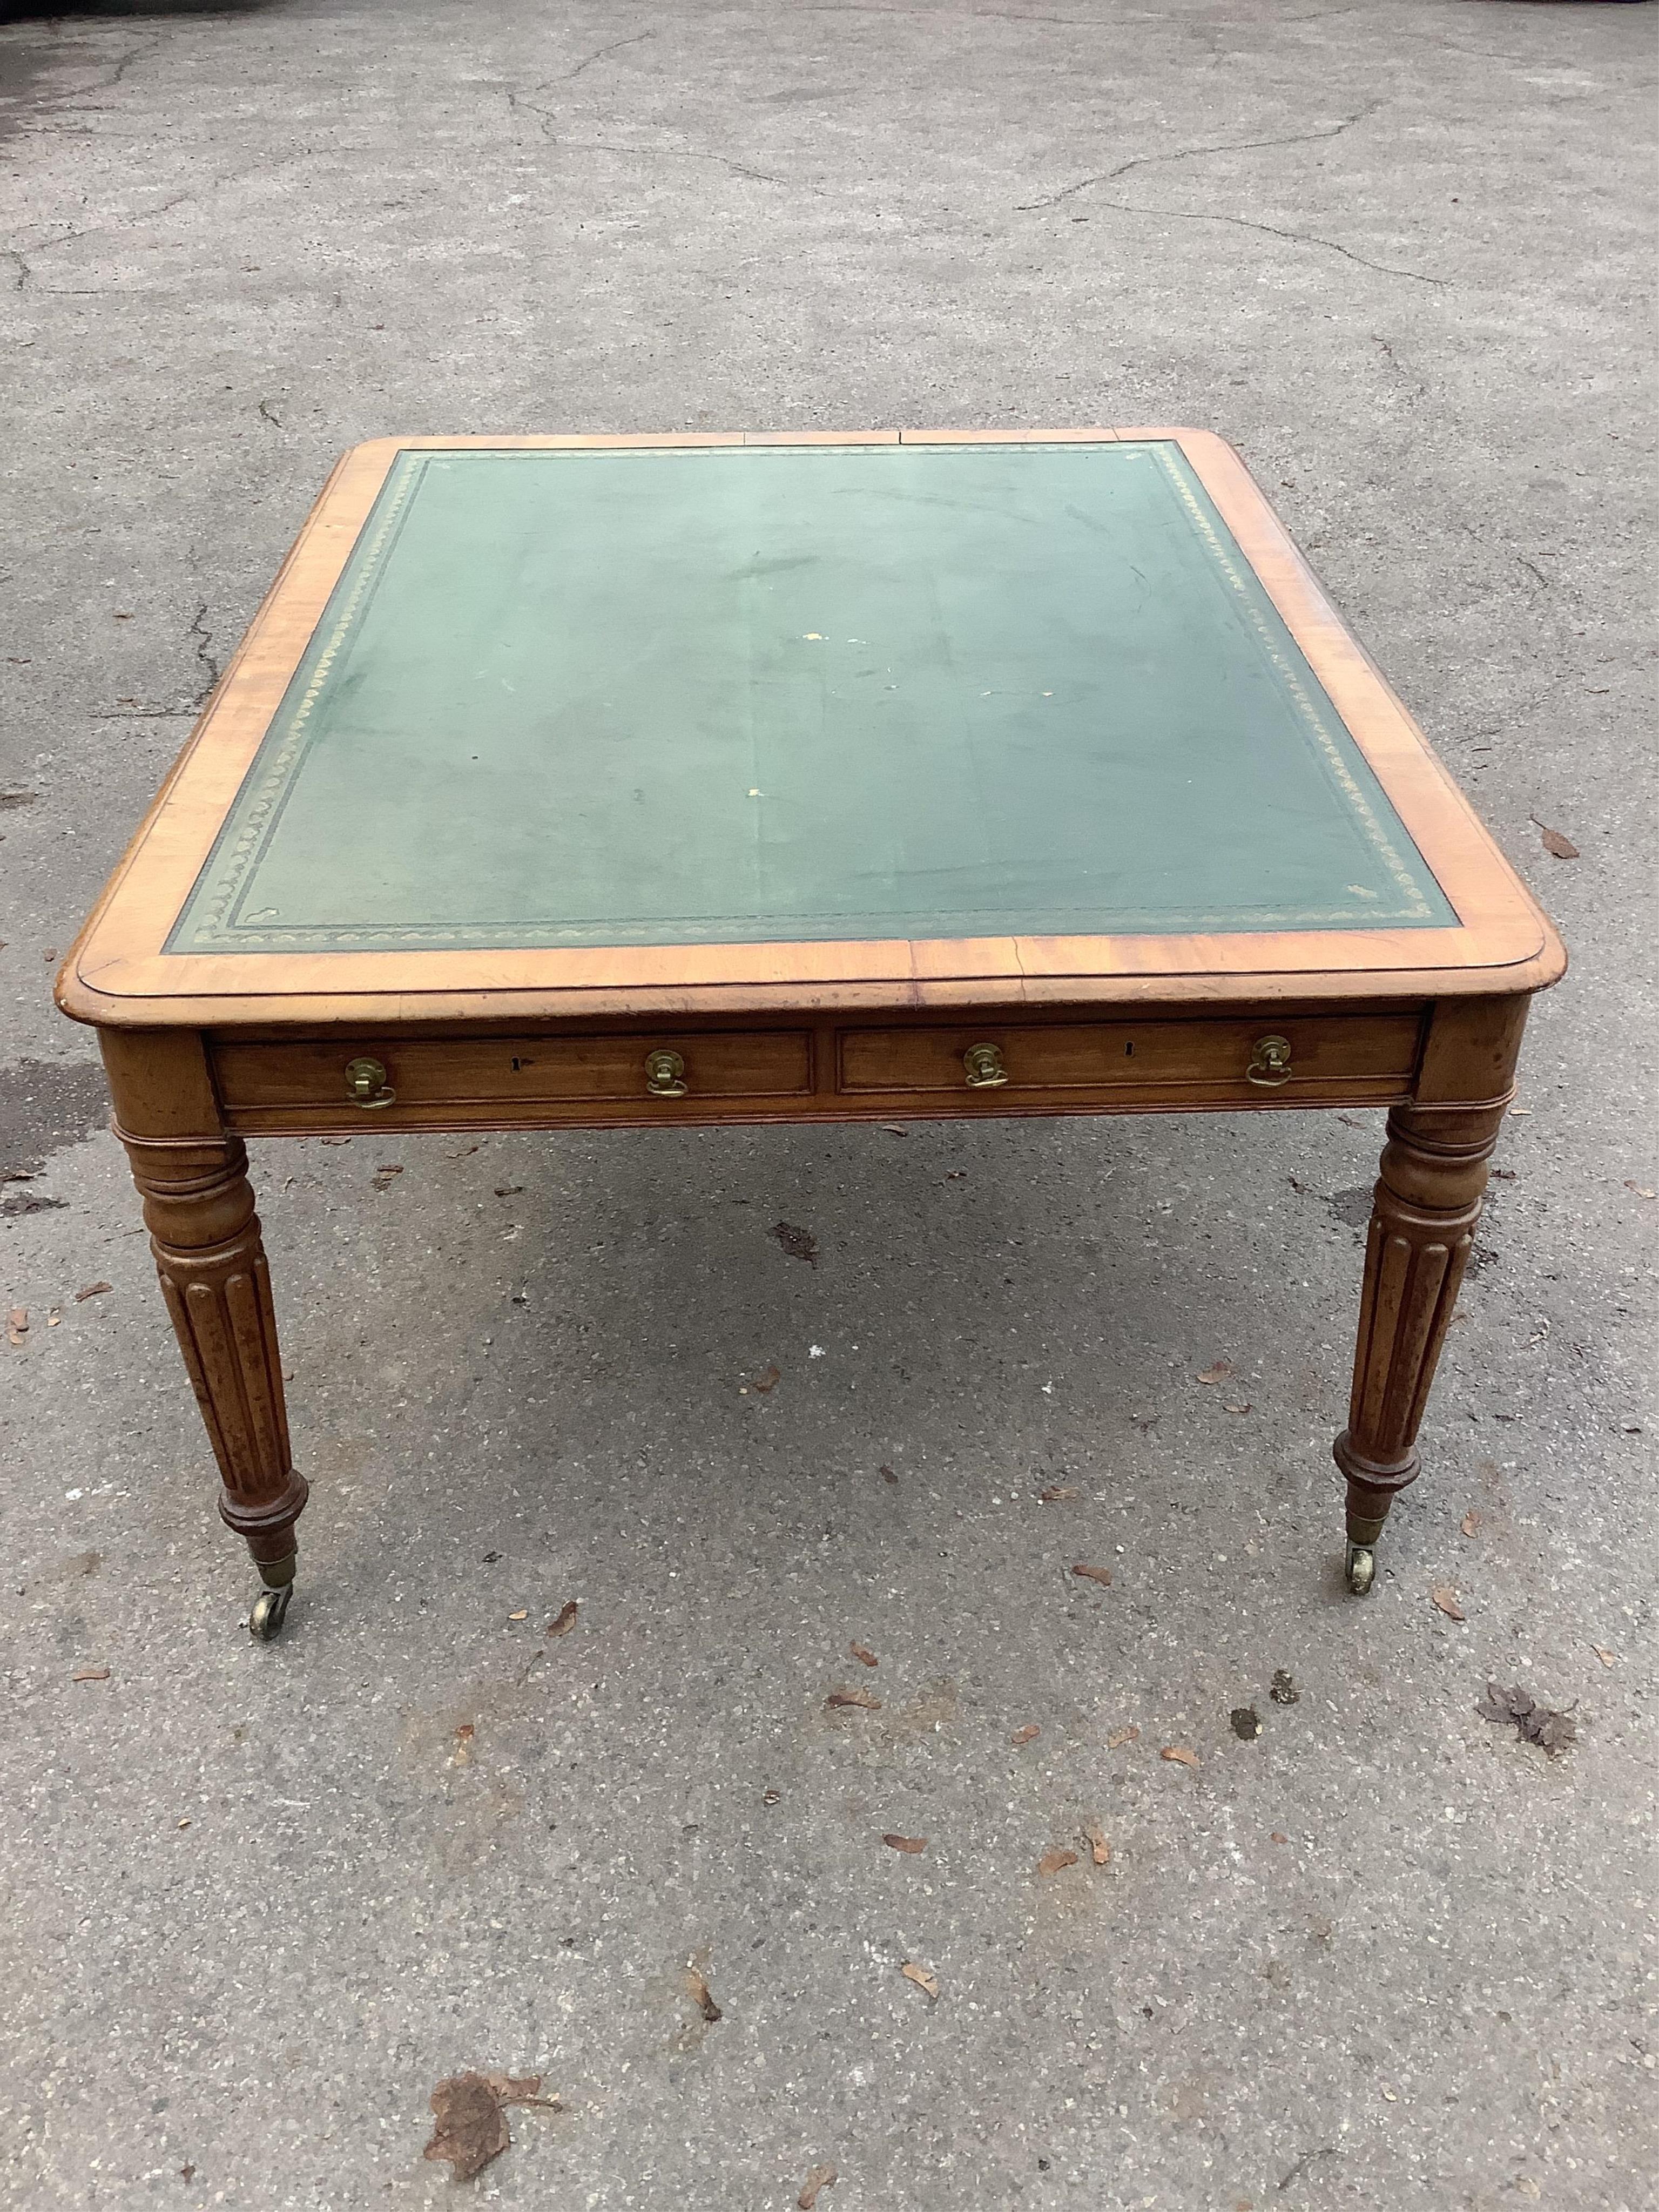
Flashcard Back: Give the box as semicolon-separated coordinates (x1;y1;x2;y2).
0;0;1659;2212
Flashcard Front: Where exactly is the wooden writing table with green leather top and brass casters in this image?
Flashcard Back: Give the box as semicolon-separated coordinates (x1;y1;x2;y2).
57;429;1566;1637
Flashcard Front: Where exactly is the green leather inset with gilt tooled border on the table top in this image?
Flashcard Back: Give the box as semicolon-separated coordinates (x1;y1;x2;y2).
168;440;1455;953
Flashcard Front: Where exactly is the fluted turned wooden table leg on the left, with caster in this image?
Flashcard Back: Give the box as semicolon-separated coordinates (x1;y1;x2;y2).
126;1137;305;1637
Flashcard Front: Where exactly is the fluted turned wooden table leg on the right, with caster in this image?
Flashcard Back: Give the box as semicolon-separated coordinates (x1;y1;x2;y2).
1334;1102;1504;1593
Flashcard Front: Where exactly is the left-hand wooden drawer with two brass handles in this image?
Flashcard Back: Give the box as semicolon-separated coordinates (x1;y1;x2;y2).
212;1031;812;1120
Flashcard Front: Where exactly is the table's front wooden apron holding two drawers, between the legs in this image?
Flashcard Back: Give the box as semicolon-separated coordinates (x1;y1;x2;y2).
206;1009;1425;1135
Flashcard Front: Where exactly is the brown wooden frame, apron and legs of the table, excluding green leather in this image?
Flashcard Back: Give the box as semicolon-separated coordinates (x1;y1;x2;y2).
57;431;1564;1628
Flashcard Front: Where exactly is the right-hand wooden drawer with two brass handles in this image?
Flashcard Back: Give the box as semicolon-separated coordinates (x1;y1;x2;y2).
836;1013;1422;1106
